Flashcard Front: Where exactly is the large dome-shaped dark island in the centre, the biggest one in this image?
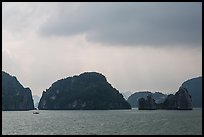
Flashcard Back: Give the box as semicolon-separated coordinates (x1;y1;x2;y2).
38;72;131;110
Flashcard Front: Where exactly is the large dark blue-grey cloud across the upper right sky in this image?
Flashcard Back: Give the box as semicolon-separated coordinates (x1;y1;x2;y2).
40;2;202;46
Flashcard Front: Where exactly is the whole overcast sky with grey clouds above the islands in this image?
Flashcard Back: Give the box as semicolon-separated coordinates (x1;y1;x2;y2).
2;2;202;96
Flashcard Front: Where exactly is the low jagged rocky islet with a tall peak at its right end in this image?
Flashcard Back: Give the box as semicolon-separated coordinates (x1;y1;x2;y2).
138;87;192;110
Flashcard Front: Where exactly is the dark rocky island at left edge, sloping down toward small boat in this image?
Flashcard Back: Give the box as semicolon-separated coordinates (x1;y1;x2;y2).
2;71;34;110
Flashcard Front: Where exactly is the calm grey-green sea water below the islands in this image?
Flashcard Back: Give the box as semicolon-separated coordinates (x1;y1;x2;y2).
2;108;202;135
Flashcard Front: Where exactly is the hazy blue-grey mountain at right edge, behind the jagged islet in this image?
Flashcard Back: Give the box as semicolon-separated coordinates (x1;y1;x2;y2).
182;76;202;107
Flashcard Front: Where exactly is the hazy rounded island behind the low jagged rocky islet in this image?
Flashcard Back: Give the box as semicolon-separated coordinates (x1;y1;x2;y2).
127;91;167;108
